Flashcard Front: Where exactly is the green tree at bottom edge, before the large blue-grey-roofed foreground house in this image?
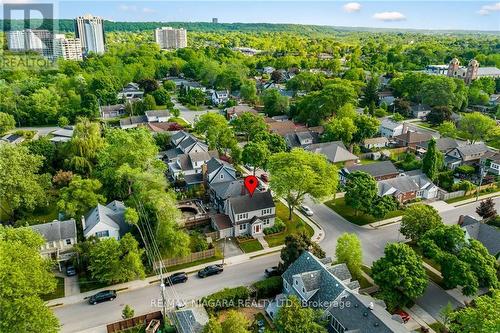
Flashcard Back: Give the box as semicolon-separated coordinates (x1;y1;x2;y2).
274;296;327;333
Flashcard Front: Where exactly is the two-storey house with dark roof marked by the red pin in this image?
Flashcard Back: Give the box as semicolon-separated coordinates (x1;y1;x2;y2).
212;186;276;237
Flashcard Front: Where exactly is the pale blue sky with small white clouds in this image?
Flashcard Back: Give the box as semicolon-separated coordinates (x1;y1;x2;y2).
5;0;500;31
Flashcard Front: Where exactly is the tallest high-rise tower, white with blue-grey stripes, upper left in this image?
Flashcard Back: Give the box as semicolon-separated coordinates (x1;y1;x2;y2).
75;14;106;54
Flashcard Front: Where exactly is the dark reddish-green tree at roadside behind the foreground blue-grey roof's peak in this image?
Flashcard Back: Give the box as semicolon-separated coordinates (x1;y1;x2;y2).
280;233;325;272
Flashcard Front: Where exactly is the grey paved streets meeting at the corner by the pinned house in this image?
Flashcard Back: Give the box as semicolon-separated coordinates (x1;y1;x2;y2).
54;198;500;332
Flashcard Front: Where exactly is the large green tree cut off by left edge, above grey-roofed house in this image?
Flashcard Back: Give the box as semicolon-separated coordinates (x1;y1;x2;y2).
0;144;50;222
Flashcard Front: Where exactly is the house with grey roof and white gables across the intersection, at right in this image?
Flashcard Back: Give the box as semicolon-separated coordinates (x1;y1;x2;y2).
377;172;439;203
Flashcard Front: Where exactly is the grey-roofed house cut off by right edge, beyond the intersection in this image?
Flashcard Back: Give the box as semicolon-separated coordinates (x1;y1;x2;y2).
458;215;500;260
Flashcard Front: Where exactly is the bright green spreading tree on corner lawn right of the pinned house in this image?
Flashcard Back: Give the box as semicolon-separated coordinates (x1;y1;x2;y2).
269;149;338;220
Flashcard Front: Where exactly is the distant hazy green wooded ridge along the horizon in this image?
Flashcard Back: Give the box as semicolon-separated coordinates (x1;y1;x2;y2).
0;19;496;35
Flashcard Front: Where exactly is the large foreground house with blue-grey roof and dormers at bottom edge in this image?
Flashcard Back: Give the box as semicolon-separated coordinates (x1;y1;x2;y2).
266;251;409;333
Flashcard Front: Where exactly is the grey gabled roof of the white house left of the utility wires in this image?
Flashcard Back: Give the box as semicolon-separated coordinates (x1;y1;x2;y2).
83;200;130;236
